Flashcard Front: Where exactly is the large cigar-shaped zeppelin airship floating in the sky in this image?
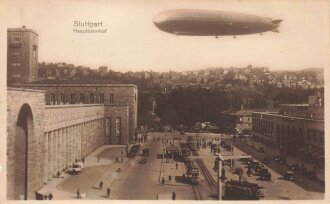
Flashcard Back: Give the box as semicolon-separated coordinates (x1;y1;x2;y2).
154;9;282;37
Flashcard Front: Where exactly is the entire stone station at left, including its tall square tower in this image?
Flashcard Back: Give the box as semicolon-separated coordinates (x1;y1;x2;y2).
6;28;138;200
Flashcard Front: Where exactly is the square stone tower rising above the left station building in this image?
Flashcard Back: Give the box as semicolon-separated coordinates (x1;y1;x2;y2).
7;26;38;84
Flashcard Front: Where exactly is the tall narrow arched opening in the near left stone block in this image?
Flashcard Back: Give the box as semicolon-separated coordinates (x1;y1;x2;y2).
12;104;34;200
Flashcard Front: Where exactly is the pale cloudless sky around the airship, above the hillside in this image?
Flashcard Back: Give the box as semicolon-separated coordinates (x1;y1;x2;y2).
5;0;329;72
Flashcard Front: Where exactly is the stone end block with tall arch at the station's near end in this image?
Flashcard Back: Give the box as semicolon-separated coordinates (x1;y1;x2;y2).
7;88;45;199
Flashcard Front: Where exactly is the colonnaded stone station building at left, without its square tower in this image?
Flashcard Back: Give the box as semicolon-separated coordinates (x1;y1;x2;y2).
7;85;137;200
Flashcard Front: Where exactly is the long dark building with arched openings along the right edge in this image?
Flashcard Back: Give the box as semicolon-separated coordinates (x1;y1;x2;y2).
252;91;325;166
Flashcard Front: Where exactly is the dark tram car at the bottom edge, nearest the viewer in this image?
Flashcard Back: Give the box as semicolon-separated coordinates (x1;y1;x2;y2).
224;180;265;200
